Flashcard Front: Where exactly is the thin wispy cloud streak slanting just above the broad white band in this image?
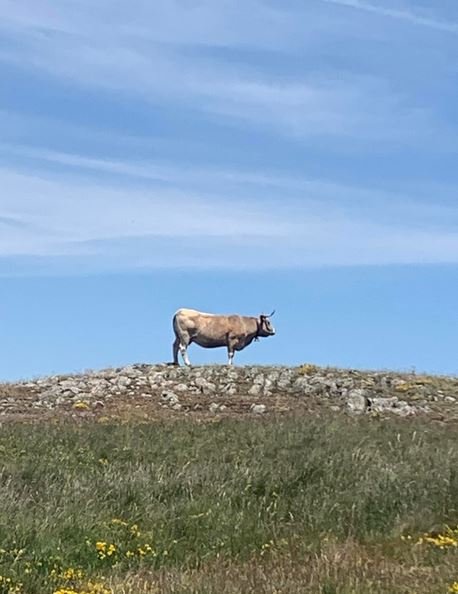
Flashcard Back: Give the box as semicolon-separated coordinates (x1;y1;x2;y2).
0;143;458;227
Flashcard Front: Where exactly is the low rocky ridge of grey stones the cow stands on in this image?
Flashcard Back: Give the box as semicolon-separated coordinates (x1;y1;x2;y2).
0;364;458;421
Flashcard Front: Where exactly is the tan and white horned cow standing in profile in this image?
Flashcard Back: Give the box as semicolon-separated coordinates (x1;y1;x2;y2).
173;309;275;366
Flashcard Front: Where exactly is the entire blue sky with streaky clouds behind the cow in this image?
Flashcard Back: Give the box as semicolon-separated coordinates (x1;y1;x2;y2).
0;0;458;379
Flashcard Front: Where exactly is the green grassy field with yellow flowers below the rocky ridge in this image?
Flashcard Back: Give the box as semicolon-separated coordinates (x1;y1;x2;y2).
0;415;458;594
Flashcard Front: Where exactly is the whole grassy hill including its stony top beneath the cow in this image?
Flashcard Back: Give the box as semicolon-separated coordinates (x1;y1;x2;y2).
0;366;458;594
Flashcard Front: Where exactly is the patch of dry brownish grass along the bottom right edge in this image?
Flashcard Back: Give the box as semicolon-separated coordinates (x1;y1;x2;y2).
111;540;457;594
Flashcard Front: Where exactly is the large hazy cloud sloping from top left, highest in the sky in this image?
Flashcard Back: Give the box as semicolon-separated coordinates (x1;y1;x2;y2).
0;0;436;143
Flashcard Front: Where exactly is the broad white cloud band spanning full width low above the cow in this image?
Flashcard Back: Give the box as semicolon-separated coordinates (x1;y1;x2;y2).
0;154;458;270
